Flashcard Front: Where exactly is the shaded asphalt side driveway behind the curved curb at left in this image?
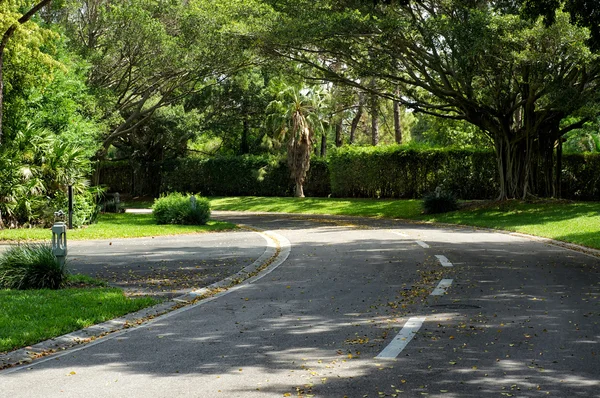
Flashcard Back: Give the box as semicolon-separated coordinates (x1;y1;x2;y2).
68;231;265;298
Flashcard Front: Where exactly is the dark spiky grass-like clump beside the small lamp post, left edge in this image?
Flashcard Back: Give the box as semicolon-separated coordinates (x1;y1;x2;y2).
0;243;68;290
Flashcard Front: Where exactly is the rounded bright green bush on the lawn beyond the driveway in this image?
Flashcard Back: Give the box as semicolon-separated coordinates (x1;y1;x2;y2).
152;192;210;225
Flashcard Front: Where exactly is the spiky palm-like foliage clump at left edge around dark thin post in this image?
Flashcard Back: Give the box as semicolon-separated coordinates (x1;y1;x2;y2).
0;125;97;227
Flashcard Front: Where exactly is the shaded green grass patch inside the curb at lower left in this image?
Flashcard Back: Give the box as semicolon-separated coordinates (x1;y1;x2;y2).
0;275;158;352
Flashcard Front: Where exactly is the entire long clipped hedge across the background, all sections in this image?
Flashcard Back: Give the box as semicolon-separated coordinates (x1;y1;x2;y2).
100;146;600;200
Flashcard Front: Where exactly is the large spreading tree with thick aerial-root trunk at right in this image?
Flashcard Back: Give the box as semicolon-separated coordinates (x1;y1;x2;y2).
266;0;600;199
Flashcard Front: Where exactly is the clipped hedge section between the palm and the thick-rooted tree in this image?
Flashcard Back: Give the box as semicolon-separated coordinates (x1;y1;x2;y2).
329;146;497;199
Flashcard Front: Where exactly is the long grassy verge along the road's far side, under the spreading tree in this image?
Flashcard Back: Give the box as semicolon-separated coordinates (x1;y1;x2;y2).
211;197;600;249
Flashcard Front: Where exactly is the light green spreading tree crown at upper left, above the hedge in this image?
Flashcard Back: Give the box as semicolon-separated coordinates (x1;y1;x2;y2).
64;0;269;156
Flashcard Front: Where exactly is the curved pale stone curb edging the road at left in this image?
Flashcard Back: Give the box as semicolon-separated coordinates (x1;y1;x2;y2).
0;226;291;373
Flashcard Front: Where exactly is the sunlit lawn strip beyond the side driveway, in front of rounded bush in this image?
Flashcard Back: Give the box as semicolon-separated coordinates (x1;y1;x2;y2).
0;213;236;241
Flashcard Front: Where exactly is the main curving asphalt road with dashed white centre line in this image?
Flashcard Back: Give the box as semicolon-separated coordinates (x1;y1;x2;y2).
0;213;600;398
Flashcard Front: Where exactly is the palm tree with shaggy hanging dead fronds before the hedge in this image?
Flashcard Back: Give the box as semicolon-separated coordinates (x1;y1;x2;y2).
267;83;326;198
